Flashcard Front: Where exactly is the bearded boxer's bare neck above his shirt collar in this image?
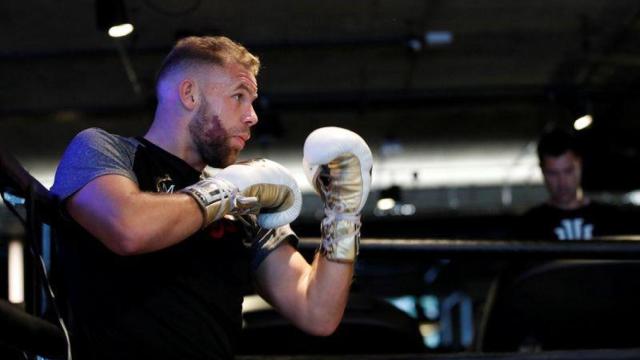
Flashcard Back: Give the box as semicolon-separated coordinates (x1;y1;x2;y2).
144;105;205;171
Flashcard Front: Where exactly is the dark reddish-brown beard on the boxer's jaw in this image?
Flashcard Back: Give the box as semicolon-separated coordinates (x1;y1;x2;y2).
189;97;238;168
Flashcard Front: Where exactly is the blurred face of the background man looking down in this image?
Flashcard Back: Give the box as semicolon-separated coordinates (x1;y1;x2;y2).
540;151;582;207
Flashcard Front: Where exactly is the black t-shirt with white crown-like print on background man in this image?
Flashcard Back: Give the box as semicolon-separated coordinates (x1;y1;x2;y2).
516;201;634;240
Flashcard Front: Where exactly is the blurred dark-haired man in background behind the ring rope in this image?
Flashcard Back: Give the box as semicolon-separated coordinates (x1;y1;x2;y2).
517;129;625;240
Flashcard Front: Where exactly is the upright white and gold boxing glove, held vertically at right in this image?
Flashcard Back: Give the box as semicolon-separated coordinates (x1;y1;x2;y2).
302;127;373;262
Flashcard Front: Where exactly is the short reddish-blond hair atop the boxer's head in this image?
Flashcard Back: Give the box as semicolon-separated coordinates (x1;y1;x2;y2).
156;36;260;95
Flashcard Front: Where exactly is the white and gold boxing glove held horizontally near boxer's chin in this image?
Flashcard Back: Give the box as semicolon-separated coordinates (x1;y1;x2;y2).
181;159;302;229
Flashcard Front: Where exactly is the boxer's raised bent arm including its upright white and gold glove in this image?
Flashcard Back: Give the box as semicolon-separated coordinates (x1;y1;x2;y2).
258;127;373;335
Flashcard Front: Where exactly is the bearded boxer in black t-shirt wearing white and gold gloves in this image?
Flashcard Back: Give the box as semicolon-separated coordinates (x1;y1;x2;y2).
51;37;371;360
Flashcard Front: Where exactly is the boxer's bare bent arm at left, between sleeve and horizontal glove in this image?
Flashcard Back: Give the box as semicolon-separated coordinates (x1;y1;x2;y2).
66;175;202;255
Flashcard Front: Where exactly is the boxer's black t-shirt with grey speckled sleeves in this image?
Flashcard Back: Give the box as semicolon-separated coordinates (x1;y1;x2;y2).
52;129;295;359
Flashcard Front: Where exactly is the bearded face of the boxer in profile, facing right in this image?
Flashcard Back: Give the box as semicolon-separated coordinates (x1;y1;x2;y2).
189;64;258;167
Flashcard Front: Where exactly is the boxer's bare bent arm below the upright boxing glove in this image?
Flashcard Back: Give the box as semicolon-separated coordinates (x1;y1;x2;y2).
257;244;353;336
